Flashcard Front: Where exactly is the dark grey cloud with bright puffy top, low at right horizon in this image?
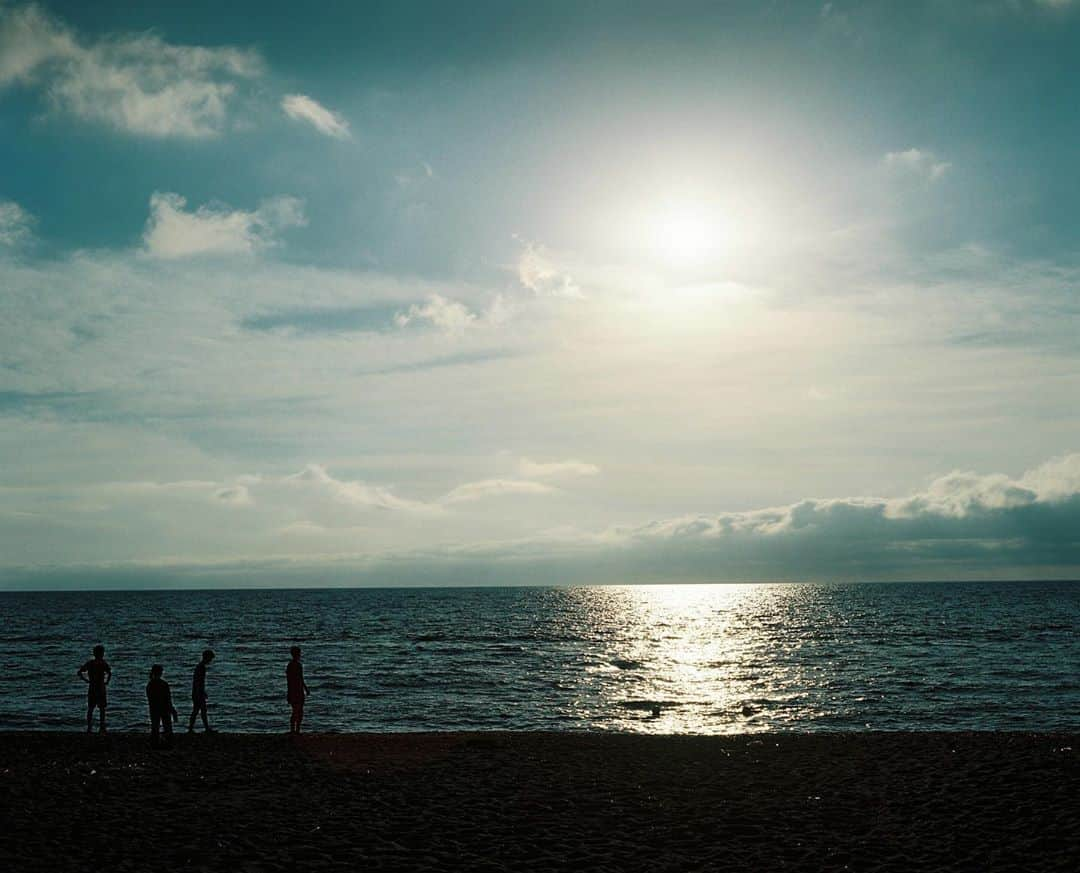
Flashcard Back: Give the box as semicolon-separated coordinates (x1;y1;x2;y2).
616;454;1080;578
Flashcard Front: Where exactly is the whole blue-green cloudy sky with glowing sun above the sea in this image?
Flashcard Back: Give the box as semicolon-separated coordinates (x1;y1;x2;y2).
0;0;1080;588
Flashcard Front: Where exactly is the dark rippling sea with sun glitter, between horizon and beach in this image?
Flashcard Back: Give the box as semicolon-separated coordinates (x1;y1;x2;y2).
0;582;1080;734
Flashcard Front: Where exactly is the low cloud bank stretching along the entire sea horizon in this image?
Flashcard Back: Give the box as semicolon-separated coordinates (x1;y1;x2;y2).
0;454;1080;588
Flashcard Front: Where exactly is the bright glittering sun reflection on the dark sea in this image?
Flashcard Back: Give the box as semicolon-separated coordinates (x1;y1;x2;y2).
576;585;793;733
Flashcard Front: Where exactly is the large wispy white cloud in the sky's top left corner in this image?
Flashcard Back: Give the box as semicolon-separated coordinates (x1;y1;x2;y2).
0;4;264;138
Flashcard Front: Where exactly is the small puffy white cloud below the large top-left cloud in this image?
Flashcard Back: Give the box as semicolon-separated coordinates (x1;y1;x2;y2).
143;191;307;259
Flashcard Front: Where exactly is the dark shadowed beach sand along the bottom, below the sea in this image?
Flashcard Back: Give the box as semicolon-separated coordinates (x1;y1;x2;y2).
0;733;1080;873
